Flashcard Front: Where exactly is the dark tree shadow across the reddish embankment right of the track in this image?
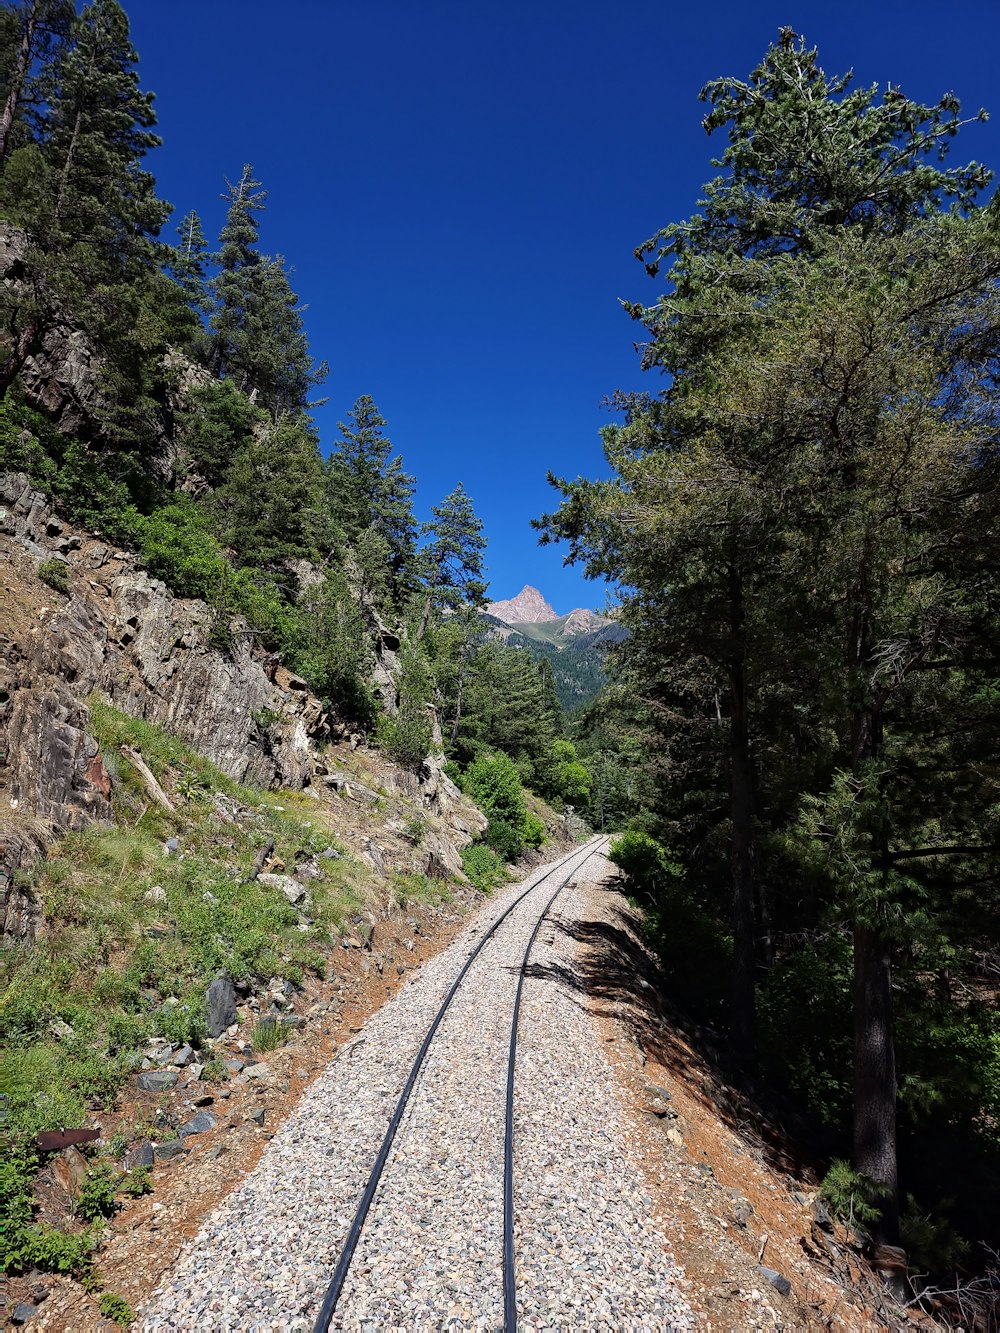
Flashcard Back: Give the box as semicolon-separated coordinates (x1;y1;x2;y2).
525;882;836;1182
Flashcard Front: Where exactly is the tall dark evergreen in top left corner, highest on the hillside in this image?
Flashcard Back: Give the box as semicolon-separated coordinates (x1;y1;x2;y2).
0;0;182;444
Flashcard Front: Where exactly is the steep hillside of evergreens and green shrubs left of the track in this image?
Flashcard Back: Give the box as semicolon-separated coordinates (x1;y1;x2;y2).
0;0;600;826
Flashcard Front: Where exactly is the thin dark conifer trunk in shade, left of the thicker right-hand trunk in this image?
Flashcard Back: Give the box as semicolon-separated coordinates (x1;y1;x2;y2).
729;568;756;1069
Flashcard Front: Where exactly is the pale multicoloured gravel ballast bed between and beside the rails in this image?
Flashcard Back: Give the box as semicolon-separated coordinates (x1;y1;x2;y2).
140;844;691;1333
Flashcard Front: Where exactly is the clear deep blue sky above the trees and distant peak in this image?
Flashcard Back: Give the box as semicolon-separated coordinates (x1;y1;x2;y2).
124;0;1000;612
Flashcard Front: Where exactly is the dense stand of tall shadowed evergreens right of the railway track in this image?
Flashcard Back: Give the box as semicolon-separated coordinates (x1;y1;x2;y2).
544;29;1000;1301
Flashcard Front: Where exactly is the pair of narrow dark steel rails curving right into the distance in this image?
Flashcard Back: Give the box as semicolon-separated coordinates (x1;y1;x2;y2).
313;837;611;1333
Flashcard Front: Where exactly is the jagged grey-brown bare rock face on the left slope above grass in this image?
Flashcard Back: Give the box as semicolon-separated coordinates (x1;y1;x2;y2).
0;473;337;829
